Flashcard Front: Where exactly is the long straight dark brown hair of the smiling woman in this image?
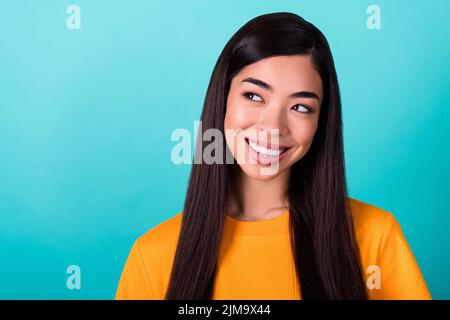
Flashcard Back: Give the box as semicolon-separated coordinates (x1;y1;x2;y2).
165;12;368;299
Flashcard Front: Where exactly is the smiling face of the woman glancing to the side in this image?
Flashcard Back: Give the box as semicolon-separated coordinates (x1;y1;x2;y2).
224;55;323;179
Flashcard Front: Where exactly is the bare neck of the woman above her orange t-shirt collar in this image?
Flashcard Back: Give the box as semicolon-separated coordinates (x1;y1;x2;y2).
227;167;290;221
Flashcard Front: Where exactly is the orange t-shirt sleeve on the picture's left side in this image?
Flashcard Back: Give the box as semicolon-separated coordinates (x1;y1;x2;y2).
115;239;154;300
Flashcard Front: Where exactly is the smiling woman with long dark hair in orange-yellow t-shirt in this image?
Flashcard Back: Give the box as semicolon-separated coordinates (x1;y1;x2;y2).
116;13;431;299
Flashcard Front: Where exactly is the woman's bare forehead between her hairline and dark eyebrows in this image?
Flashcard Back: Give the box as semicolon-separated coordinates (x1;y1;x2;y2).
234;55;322;95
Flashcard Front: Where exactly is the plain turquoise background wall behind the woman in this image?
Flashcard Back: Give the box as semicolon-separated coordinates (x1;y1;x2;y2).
0;0;450;299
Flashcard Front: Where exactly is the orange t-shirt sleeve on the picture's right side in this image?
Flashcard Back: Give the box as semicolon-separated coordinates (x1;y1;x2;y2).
374;213;431;300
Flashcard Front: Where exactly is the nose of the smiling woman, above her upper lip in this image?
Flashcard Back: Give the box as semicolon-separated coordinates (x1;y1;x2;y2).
257;103;288;136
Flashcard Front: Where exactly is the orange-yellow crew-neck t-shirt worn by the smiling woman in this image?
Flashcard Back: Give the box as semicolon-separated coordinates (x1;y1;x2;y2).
115;198;431;300
